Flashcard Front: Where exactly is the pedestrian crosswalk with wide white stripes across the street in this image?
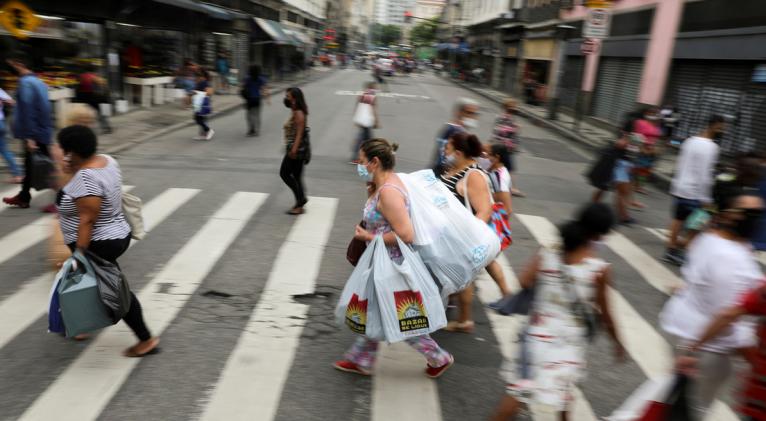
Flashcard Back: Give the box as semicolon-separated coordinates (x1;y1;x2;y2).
0;187;752;421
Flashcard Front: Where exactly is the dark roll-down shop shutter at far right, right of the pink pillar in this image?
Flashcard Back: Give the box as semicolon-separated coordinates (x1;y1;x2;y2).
667;60;766;154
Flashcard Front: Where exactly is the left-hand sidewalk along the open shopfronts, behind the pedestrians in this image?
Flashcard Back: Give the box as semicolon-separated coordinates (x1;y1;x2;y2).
0;67;332;168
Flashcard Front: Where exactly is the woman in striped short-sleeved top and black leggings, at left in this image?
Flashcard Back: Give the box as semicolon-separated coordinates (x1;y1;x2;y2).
56;126;160;357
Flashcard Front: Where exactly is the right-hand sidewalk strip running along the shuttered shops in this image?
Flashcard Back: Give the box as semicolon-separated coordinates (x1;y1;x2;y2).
444;77;678;190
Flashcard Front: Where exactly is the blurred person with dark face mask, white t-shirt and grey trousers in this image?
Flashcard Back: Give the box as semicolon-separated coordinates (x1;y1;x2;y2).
660;193;764;419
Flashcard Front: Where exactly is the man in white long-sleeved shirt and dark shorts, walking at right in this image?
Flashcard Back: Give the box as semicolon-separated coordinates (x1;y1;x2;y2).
663;115;726;265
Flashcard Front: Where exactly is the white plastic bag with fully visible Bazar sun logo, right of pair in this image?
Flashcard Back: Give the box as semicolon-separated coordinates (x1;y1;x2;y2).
372;236;447;343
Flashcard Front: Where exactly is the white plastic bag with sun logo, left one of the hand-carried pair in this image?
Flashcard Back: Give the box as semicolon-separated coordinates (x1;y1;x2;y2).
335;237;387;340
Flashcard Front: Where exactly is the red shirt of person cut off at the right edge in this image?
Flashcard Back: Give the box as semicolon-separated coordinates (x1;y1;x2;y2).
740;285;766;421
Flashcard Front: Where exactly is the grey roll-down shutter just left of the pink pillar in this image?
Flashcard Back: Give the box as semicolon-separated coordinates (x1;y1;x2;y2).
593;57;643;125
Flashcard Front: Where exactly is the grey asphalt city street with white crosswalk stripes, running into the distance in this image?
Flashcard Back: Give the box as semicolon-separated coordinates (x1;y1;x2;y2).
0;69;748;421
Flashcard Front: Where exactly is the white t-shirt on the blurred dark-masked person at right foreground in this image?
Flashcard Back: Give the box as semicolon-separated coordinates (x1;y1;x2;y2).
660;233;763;353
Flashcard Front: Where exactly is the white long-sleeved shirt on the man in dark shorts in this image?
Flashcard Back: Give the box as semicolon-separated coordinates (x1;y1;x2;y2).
670;136;719;203
